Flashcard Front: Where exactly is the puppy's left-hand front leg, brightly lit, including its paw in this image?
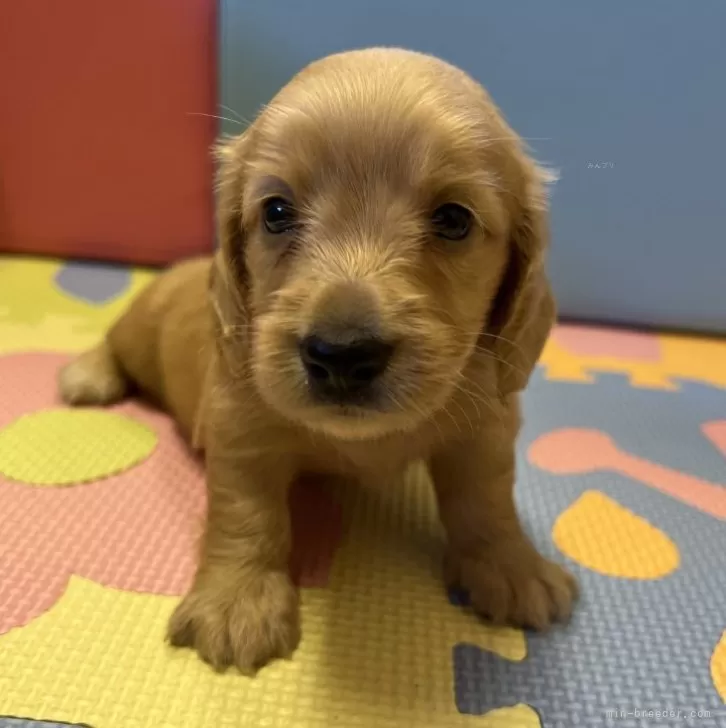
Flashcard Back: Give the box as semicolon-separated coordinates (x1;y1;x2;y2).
169;451;300;673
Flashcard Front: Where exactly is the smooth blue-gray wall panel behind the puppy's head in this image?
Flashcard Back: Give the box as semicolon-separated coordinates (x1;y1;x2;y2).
220;0;726;332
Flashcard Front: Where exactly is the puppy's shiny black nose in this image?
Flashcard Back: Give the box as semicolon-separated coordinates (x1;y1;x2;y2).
300;336;393;396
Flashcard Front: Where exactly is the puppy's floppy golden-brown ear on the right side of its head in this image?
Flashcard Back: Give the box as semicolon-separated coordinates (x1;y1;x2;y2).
484;160;556;395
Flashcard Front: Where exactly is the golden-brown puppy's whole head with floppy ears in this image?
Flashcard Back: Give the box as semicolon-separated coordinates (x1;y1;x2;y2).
214;49;552;439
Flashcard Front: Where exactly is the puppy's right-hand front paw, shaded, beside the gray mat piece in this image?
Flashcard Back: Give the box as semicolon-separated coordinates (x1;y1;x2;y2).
447;542;578;630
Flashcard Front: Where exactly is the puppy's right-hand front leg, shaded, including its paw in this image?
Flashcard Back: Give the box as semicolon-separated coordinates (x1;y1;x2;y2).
430;420;577;629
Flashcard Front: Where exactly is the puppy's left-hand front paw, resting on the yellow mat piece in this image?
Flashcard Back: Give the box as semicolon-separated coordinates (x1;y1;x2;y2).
169;572;300;674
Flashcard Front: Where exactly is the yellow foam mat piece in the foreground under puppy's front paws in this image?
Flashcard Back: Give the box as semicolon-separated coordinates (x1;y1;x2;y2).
0;470;540;728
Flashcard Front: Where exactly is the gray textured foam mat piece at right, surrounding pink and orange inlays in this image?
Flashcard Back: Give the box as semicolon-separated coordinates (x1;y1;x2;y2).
453;372;726;728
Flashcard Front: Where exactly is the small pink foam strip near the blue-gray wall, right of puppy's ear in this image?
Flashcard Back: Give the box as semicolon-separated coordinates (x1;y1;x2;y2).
552;324;661;362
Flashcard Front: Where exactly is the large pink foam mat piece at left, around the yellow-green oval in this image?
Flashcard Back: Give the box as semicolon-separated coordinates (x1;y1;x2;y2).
0;354;342;634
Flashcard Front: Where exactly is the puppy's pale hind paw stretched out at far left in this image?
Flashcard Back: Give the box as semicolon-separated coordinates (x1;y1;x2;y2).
58;339;129;405
